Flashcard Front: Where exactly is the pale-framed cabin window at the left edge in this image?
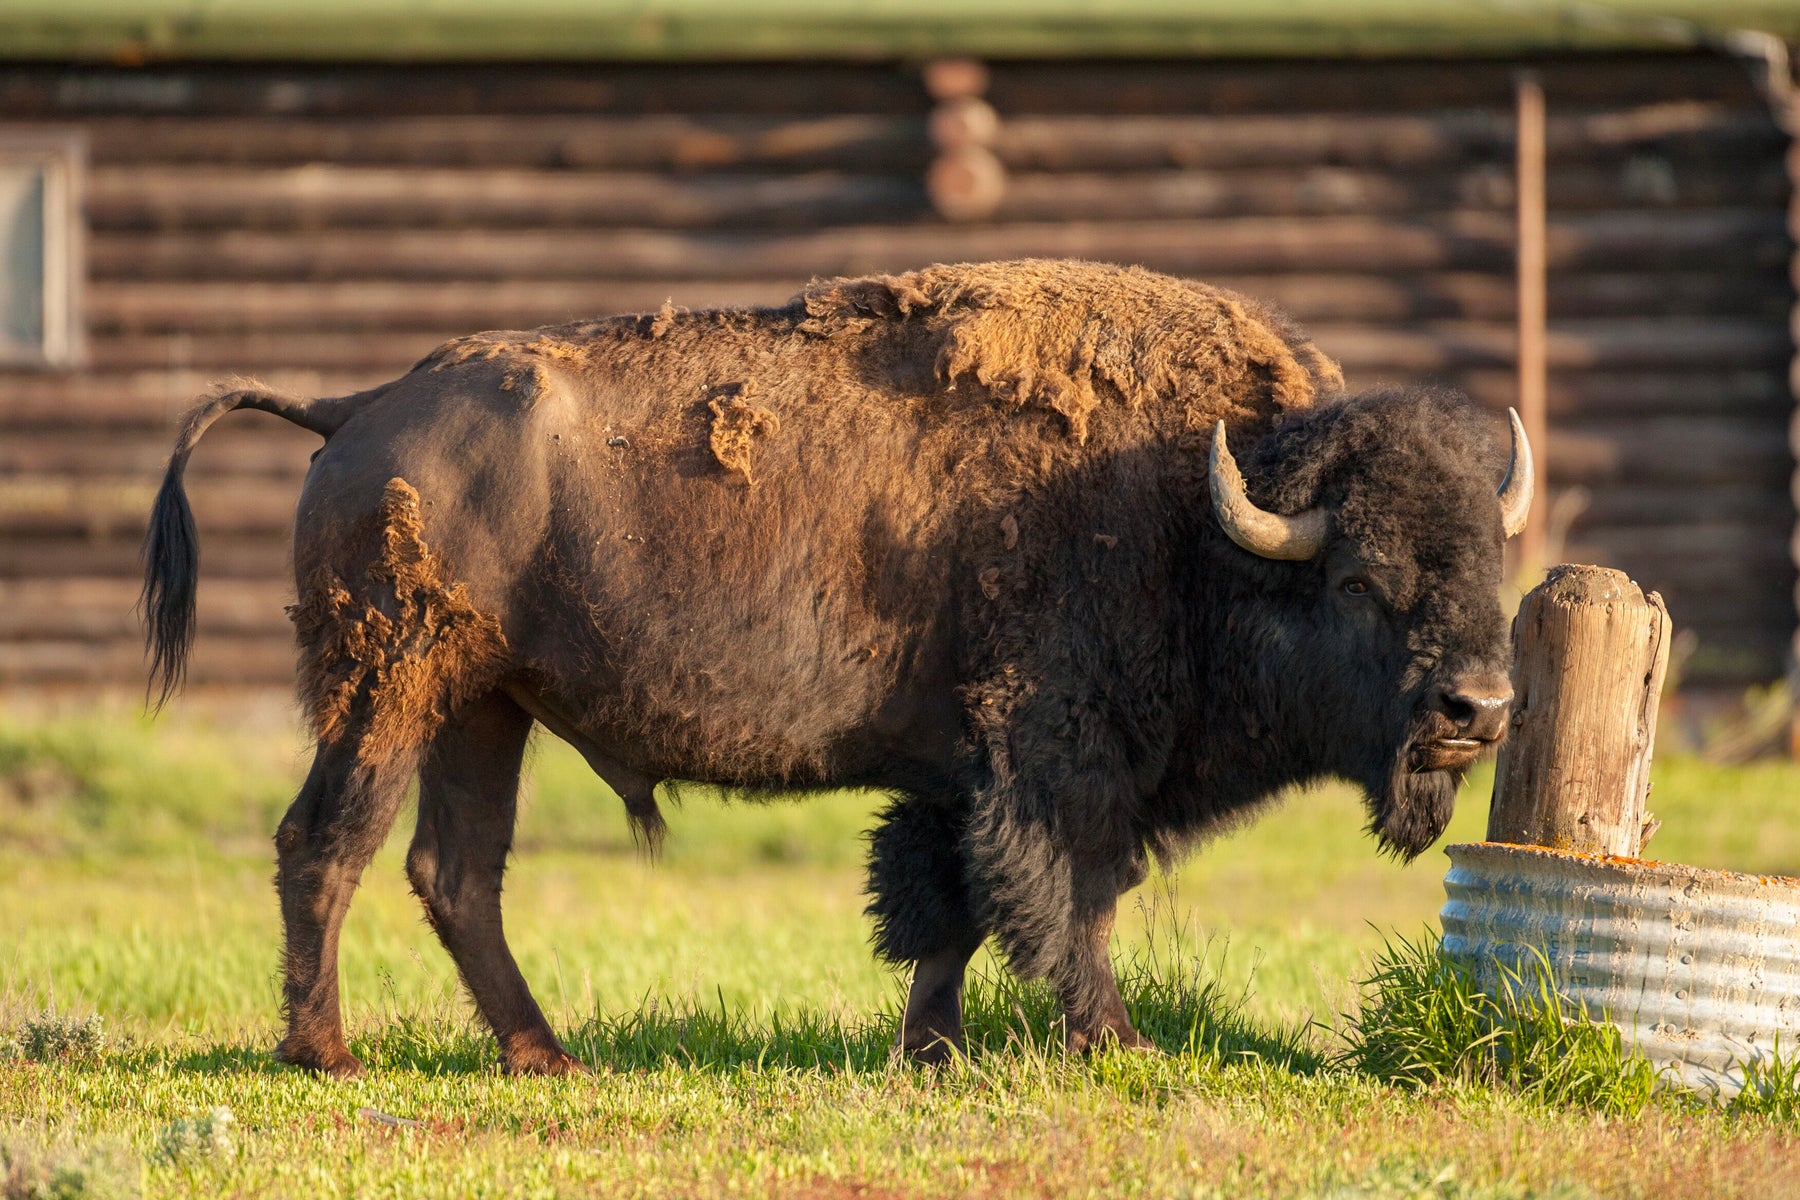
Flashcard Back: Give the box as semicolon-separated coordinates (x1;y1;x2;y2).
0;130;86;369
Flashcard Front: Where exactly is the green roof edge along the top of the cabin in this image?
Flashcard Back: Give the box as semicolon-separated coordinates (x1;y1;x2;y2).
0;0;1800;63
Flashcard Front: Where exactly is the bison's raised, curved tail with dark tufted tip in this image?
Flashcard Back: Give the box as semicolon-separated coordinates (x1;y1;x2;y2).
139;380;362;709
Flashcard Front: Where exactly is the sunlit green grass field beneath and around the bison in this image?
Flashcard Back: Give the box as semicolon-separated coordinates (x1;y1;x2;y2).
0;709;1800;1200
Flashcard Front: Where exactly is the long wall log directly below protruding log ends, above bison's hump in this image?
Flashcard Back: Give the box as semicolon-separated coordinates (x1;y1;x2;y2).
88;210;1789;282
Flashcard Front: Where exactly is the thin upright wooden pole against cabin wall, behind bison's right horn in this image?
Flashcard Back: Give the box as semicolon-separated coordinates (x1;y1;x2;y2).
1514;72;1550;572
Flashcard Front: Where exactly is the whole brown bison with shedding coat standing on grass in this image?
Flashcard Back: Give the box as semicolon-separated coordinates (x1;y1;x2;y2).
146;261;1532;1074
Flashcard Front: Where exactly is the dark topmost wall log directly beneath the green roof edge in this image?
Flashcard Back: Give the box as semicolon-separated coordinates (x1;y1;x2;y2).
0;52;1762;119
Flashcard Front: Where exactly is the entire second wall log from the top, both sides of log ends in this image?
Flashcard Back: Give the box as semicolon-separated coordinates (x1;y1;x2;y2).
70;103;1786;171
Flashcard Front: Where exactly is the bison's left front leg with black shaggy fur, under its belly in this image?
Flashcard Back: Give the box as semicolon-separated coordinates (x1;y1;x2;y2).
868;797;986;1063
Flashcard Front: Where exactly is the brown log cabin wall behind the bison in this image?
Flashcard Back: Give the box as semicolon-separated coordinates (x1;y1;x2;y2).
0;54;1796;689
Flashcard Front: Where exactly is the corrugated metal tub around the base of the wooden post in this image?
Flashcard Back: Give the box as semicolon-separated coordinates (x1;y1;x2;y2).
1442;842;1800;1096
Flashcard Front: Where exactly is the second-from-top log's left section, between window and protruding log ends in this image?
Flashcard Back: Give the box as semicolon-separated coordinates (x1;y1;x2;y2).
86;113;931;173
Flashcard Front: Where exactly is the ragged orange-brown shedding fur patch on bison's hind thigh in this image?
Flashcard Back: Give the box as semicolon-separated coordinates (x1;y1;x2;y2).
288;479;506;763
